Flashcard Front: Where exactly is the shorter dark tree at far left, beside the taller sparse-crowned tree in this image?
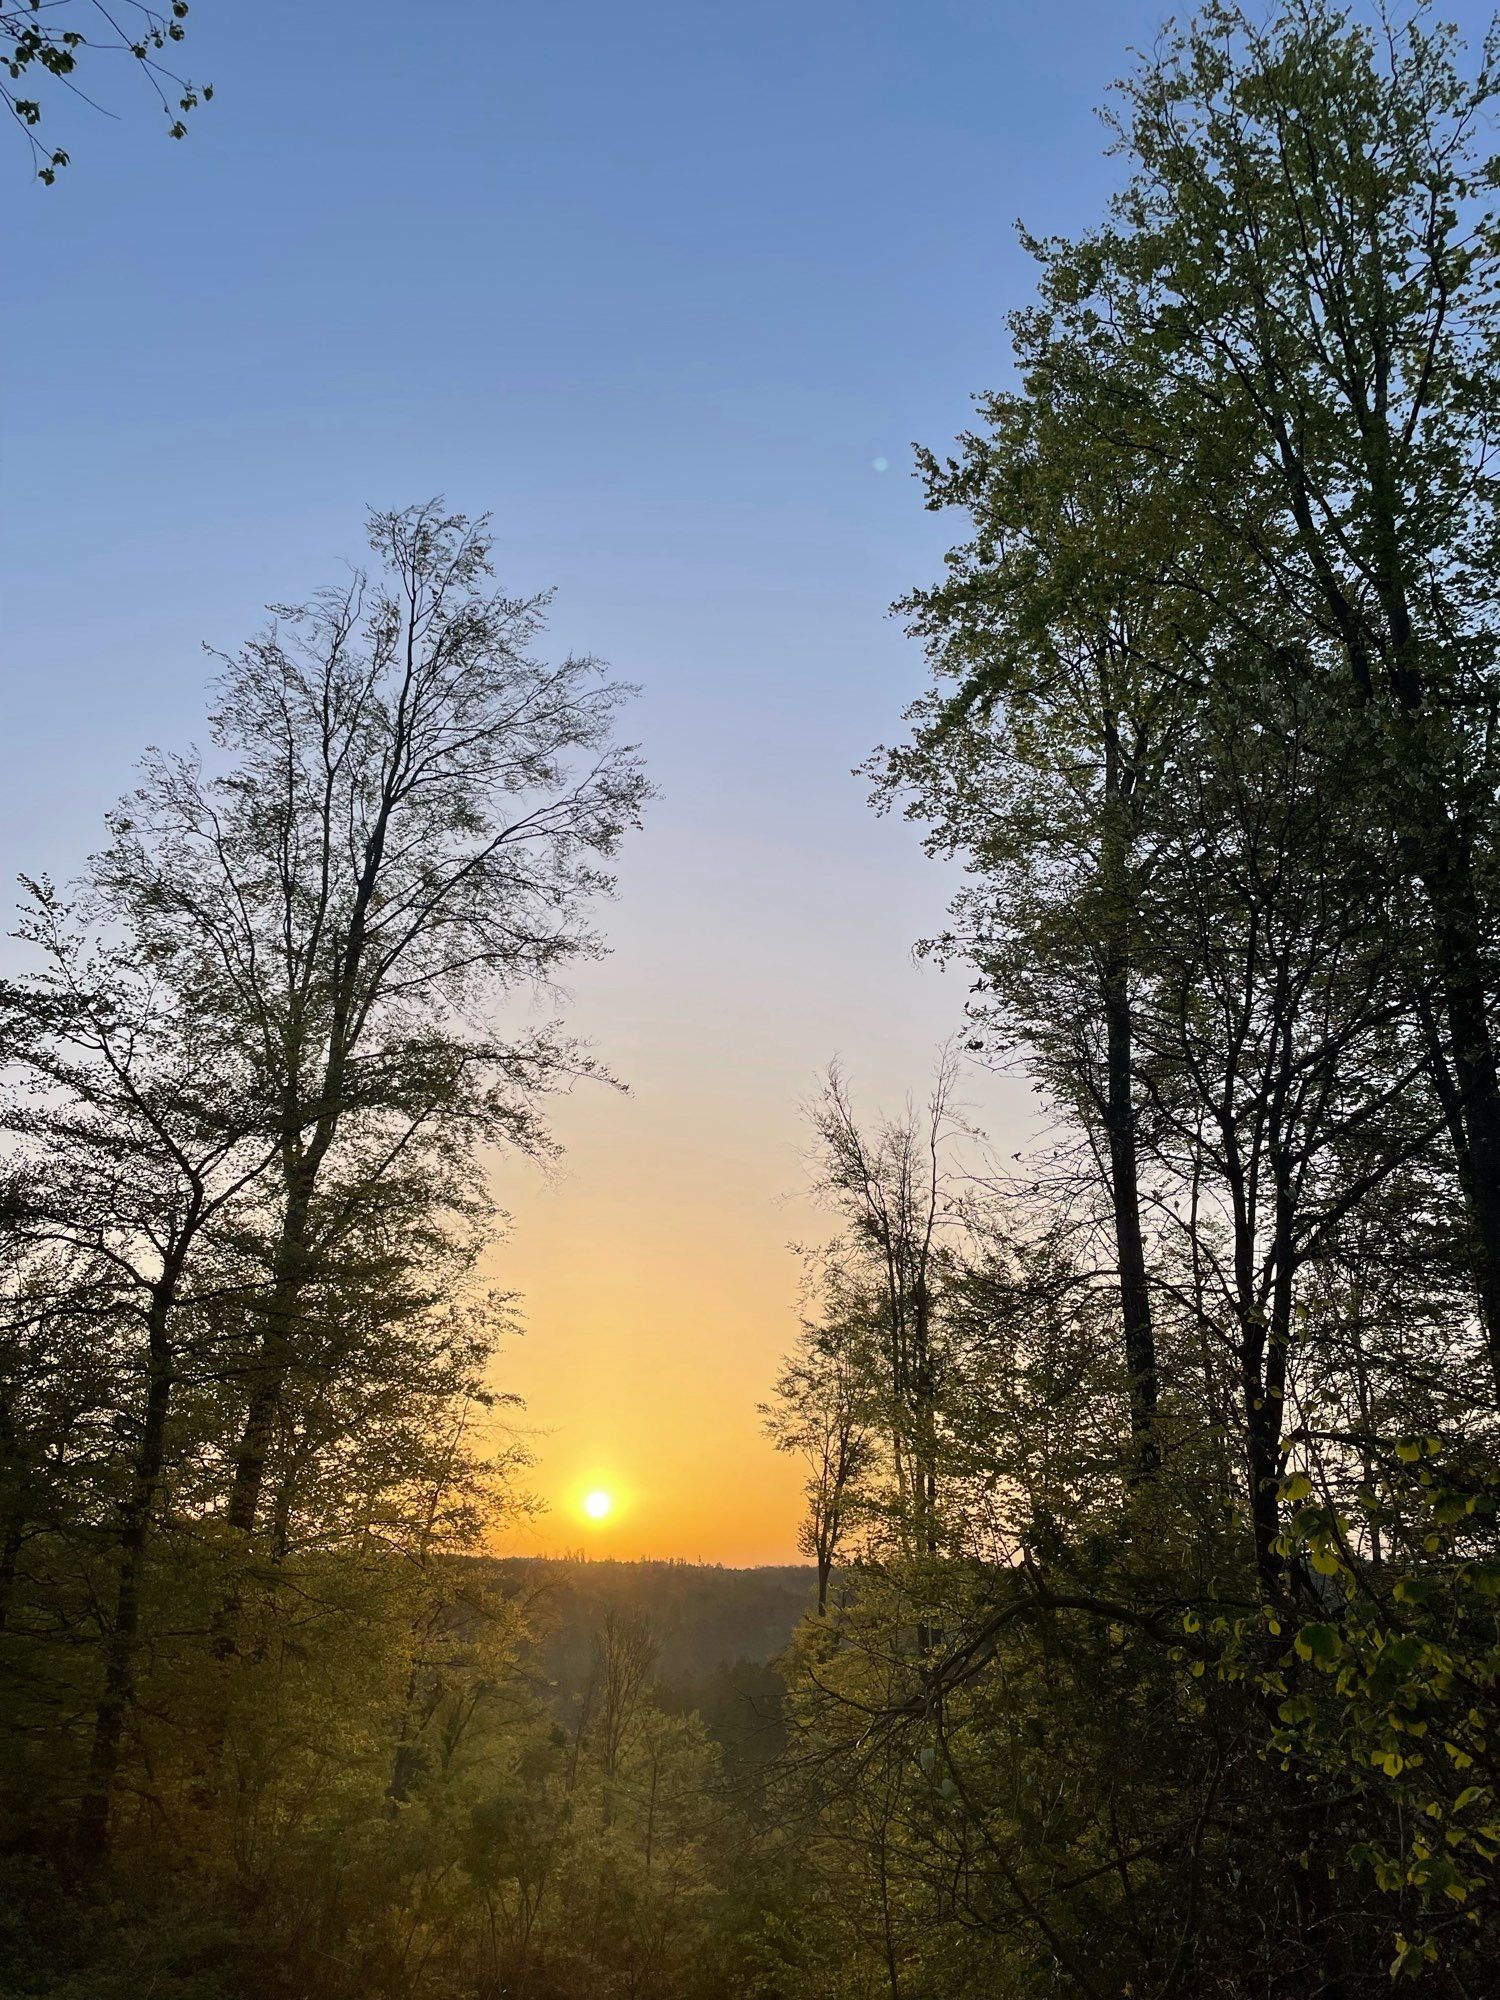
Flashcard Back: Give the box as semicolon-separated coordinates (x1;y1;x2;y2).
0;882;274;1856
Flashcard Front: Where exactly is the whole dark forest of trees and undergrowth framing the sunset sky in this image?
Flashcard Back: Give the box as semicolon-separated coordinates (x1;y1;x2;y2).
0;0;1500;2000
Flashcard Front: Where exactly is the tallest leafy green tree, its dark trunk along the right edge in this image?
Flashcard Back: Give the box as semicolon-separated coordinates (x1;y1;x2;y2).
1034;0;1500;1388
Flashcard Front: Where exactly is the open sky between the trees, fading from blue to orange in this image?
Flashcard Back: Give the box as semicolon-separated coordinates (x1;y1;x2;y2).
11;0;1482;1562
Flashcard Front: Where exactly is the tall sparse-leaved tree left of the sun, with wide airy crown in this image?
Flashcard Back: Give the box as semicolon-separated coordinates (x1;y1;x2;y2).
92;506;646;1592
